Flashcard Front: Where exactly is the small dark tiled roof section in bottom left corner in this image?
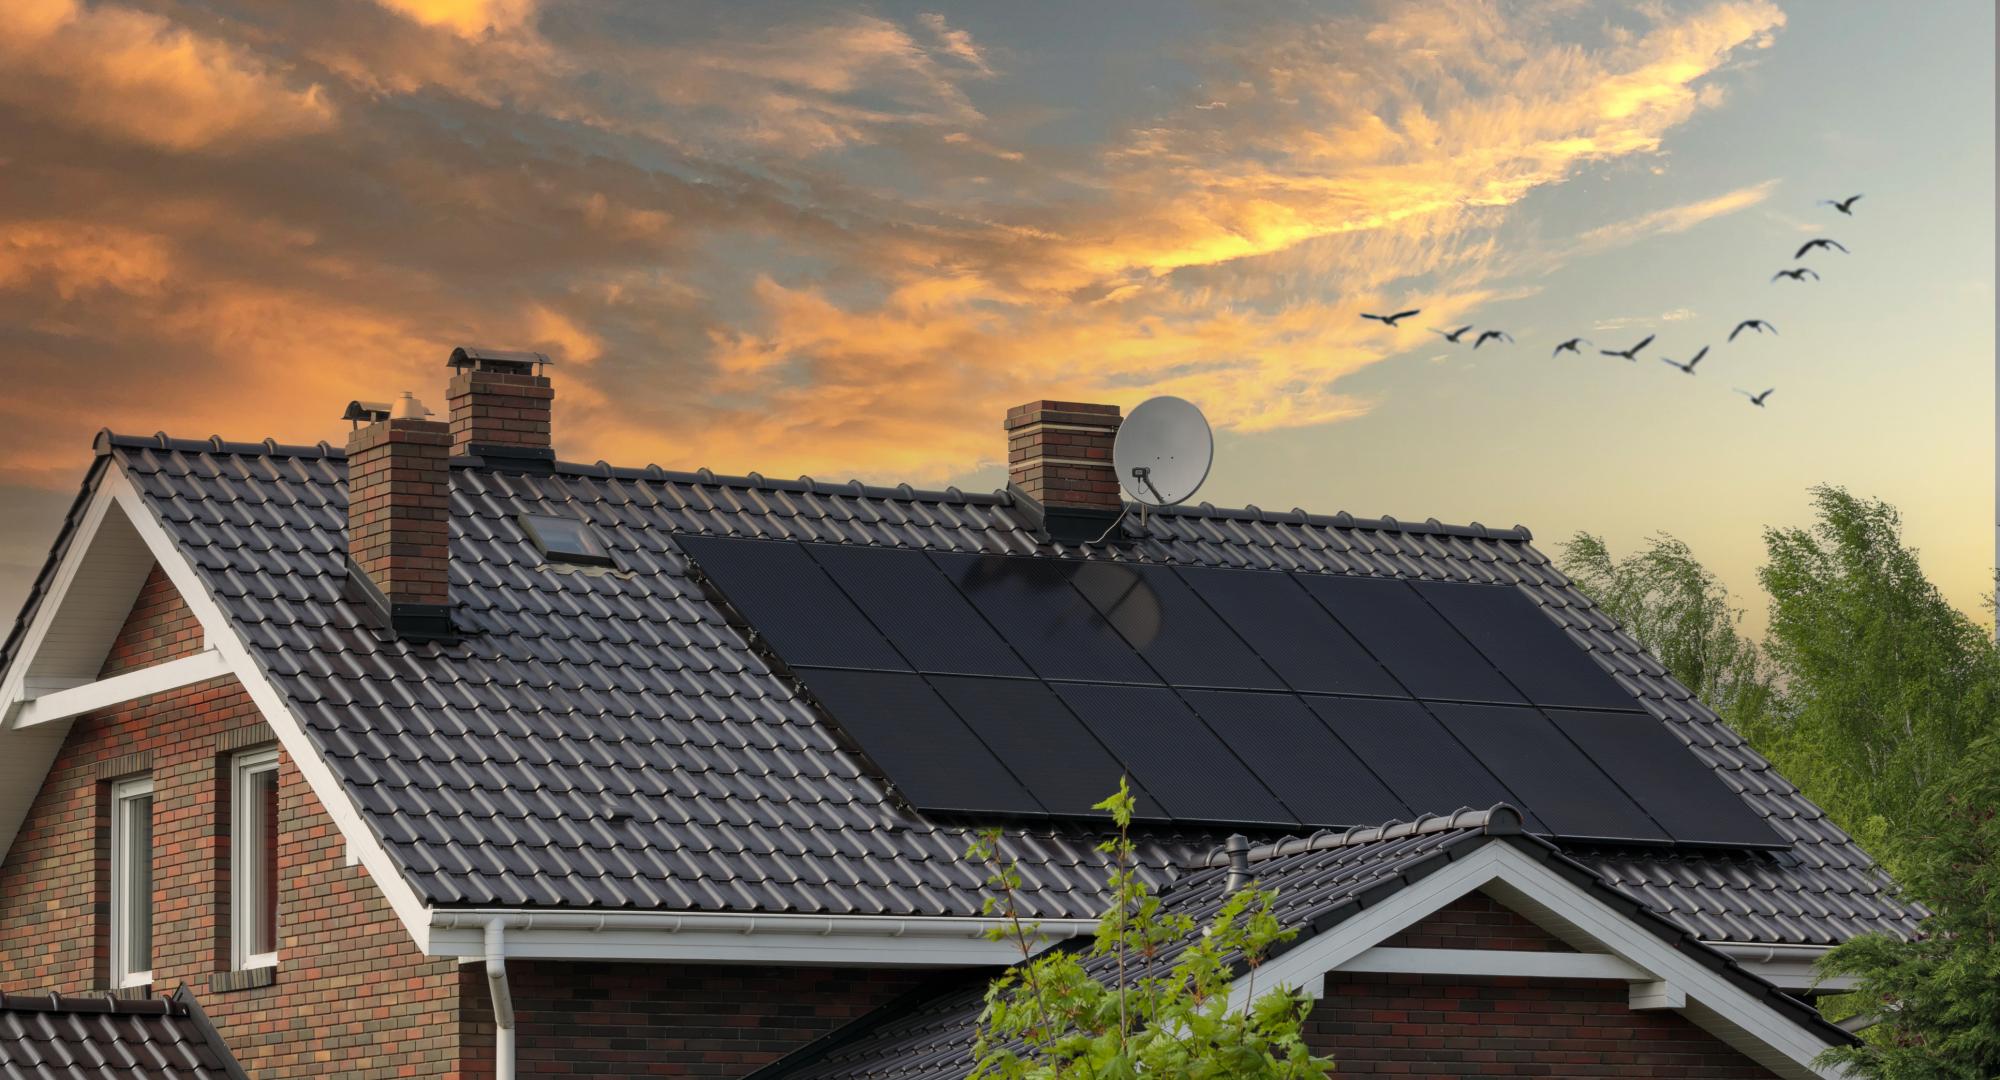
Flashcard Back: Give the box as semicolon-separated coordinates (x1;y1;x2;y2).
0;986;244;1080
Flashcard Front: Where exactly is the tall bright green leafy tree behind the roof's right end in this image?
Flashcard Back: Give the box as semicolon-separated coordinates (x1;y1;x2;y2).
1744;486;2000;876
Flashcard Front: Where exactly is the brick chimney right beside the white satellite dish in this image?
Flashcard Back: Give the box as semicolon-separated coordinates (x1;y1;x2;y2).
1006;402;1124;542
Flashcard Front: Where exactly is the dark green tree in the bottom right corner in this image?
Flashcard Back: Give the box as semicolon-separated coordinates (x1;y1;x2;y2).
1820;734;2000;1080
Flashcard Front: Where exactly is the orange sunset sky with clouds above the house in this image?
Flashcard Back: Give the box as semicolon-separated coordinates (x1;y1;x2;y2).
0;0;1996;632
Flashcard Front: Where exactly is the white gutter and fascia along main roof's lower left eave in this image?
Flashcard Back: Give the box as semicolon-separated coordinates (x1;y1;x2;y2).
426;910;1098;968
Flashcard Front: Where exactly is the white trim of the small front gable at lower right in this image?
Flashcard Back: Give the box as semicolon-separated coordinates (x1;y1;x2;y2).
1230;840;1846;1080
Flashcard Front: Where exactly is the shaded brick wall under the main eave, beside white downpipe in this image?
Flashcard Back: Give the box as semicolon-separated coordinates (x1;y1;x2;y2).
460;960;924;1078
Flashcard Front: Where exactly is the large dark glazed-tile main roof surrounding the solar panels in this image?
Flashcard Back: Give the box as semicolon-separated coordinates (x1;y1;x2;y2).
7;432;1914;944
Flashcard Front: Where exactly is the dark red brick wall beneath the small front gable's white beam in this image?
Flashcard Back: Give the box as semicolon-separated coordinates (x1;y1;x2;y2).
1304;974;1772;1080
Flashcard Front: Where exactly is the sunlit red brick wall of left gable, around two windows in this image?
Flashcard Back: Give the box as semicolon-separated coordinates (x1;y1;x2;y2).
0;570;460;1080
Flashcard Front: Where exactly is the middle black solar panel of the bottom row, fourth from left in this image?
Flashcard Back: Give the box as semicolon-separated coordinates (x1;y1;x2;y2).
1182;690;1410;828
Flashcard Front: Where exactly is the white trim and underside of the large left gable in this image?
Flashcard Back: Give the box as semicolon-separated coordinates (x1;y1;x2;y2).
0;466;430;948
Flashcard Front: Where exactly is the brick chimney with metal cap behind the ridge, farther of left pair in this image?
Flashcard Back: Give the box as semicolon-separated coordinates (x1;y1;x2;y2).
444;346;556;462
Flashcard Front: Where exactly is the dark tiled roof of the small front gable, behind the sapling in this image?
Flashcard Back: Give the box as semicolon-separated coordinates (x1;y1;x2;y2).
754;806;1854;1080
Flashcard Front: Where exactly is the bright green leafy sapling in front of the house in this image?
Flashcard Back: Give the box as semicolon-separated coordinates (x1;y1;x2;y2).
966;782;1332;1080
